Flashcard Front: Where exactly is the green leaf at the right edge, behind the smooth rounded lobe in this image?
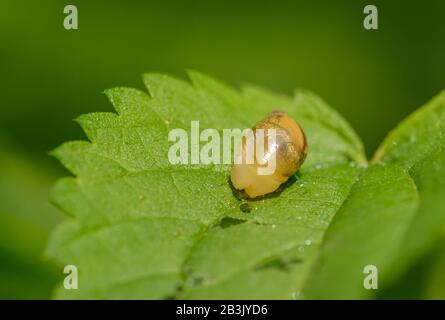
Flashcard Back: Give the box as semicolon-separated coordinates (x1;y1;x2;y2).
374;91;445;272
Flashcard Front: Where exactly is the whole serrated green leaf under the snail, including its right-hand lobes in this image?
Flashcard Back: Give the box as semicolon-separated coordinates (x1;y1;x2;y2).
48;72;444;299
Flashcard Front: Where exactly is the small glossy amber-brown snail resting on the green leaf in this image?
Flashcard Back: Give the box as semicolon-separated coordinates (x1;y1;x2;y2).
230;110;307;198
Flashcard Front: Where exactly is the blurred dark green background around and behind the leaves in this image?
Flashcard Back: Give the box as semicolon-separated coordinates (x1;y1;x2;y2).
0;0;445;298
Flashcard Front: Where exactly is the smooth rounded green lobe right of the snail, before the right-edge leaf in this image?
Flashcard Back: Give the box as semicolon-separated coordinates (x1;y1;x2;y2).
305;165;418;299
